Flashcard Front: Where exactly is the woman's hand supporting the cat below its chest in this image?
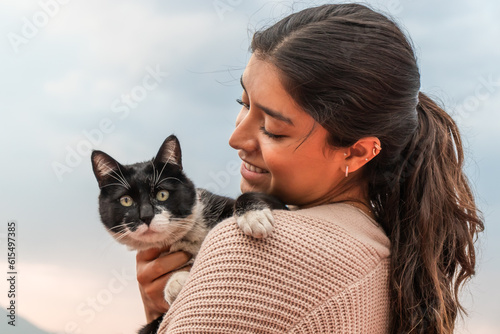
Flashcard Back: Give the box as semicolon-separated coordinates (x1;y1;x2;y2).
136;248;191;322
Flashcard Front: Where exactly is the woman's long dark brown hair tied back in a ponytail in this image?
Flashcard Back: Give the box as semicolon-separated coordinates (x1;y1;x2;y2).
251;4;484;334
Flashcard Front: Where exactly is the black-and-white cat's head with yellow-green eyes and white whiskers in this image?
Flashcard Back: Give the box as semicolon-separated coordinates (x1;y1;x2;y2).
91;135;196;249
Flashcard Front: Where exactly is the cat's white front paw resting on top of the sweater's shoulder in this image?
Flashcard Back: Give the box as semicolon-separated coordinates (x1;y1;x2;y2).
236;208;274;238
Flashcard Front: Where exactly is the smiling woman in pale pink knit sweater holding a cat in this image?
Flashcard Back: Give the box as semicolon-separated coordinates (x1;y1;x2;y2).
137;4;483;334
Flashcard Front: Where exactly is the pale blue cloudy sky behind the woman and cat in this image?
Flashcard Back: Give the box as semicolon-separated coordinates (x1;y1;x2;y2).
0;0;500;334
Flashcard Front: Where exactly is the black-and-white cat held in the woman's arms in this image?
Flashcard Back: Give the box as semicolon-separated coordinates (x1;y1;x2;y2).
91;135;288;334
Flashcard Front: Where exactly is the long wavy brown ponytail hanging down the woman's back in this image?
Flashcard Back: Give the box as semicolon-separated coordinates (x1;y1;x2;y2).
375;93;484;334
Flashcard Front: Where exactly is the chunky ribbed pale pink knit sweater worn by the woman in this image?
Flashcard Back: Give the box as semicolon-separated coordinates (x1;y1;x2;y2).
159;204;389;334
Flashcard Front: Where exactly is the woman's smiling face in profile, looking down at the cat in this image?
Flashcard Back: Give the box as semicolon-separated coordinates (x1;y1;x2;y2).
229;55;346;206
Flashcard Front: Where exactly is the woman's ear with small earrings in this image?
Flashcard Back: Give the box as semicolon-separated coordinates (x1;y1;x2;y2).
345;137;382;173
